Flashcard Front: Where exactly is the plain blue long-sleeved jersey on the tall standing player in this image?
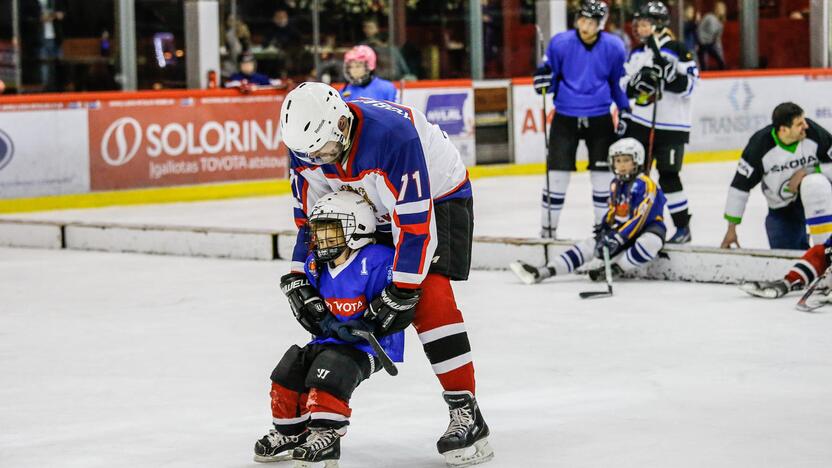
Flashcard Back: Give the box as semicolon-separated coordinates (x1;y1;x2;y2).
546;30;630;117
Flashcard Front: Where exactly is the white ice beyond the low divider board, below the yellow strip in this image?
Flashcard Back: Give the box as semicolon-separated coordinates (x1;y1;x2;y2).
1;163;768;248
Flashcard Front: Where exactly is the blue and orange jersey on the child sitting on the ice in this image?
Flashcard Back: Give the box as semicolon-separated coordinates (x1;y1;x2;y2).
604;174;667;241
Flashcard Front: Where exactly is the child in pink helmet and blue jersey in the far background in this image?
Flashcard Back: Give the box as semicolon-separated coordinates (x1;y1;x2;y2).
341;45;397;102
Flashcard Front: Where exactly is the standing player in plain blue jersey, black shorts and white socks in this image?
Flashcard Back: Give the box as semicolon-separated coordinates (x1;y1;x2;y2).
534;0;630;238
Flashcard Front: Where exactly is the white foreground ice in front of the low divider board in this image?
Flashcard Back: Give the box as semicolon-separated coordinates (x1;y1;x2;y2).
0;247;832;468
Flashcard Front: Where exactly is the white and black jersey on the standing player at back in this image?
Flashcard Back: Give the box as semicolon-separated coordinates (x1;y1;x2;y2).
620;34;699;138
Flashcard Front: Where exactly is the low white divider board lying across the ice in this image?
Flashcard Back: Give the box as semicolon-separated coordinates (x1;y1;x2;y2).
0;220;801;283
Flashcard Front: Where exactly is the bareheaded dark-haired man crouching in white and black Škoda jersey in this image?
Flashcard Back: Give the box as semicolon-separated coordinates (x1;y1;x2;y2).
721;102;832;250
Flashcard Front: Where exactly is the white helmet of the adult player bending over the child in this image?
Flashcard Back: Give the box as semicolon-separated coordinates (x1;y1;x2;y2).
280;81;352;165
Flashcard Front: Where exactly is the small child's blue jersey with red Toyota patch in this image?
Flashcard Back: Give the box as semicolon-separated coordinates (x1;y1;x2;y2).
305;244;404;362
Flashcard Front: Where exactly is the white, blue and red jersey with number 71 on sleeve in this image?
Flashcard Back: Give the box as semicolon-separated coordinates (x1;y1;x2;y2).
289;98;472;288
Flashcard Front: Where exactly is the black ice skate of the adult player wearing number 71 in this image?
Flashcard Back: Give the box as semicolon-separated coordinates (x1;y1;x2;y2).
436;391;494;467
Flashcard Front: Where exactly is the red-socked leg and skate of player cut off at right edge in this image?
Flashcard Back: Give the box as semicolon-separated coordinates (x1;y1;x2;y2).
740;237;832;299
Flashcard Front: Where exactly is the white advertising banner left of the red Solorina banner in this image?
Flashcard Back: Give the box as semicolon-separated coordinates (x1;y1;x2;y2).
0;109;90;198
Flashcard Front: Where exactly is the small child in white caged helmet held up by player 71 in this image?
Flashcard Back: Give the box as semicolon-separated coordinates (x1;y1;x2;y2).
254;191;404;466
